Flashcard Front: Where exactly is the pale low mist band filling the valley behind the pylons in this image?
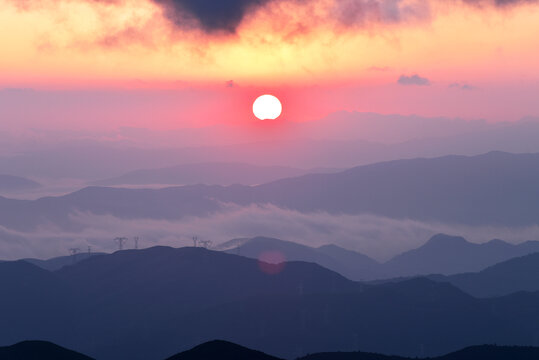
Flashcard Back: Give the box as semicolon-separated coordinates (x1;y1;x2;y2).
4;205;539;261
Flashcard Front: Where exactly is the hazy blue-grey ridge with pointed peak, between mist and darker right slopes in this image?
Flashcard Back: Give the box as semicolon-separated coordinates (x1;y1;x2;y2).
221;234;539;282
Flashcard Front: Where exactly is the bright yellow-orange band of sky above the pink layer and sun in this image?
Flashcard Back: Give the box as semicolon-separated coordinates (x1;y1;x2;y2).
0;0;539;87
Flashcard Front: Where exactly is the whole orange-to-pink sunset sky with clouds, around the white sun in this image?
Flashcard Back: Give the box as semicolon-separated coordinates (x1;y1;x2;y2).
0;0;539;131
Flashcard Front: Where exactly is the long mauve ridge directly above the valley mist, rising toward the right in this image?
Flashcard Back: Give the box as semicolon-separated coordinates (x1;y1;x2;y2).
0;152;539;230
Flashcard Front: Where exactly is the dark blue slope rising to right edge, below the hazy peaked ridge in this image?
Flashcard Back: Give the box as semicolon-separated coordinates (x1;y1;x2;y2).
431;253;539;297
